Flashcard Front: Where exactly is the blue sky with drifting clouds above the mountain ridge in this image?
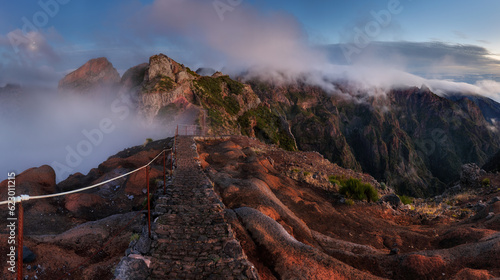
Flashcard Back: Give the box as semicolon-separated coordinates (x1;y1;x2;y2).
0;0;500;88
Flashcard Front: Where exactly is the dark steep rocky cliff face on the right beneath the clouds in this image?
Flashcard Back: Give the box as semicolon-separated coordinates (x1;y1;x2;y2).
245;81;500;196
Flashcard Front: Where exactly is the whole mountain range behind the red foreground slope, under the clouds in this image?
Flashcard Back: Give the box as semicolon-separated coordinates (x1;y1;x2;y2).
54;54;500;197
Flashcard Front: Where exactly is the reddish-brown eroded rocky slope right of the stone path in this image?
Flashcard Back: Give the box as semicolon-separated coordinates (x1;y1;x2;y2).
198;135;500;279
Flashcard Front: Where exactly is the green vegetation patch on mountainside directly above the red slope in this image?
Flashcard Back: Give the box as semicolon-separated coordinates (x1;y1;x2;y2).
238;105;297;151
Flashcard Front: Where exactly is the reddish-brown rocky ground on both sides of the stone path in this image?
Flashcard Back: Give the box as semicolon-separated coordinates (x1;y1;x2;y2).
0;134;500;279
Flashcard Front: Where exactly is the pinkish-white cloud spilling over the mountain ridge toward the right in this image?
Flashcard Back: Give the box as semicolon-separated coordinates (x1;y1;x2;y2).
130;0;500;102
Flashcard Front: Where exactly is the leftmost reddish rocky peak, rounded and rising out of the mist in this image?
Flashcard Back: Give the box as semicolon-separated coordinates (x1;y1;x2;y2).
58;57;120;93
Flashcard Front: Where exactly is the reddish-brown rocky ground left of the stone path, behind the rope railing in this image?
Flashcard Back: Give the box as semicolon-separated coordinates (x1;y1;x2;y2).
0;139;172;280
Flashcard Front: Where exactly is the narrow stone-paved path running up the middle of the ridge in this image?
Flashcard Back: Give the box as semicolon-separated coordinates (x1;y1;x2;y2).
151;137;259;279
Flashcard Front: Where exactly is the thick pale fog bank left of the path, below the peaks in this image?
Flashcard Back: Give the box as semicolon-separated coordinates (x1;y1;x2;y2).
0;88;173;181
